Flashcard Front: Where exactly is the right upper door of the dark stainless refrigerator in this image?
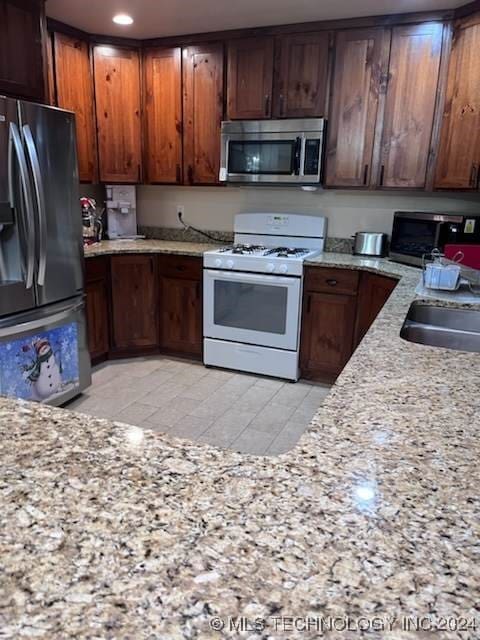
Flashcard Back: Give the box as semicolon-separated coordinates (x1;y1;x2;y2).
20;102;83;306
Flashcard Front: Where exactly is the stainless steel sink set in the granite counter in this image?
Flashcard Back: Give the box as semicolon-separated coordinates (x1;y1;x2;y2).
400;302;480;353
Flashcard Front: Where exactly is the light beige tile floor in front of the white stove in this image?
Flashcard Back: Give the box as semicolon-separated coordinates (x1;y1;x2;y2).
66;356;329;455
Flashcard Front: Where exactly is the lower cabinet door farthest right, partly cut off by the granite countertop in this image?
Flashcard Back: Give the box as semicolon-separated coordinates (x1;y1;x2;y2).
355;273;398;345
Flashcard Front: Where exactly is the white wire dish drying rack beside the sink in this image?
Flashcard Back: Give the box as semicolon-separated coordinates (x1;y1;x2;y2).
422;249;480;296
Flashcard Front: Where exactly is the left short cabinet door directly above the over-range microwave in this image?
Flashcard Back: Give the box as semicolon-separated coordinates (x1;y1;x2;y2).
227;38;274;120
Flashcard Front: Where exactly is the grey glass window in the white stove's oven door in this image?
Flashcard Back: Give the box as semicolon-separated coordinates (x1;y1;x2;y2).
213;280;288;335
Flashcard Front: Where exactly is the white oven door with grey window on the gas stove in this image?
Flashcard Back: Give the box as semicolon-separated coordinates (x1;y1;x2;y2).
203;269;301;351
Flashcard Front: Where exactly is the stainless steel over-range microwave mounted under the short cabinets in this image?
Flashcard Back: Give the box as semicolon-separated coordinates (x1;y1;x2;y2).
220;118;325;185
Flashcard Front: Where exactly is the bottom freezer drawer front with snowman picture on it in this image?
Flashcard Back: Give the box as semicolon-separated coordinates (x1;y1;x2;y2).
0;297;91;406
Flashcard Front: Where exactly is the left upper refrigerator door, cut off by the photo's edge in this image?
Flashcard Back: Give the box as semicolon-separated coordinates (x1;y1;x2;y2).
0;96;36;317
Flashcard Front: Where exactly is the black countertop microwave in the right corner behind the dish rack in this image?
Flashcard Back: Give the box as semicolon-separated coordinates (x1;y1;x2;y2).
390;211;480;266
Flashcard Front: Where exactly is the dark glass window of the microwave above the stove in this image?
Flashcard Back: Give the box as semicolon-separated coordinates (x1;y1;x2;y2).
228;140;296;175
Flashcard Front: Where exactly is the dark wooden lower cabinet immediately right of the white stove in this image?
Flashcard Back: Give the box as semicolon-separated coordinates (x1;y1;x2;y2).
300;267;397;382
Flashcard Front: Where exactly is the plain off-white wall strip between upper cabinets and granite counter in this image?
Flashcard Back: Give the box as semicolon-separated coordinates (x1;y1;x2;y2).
137;186;480;238
